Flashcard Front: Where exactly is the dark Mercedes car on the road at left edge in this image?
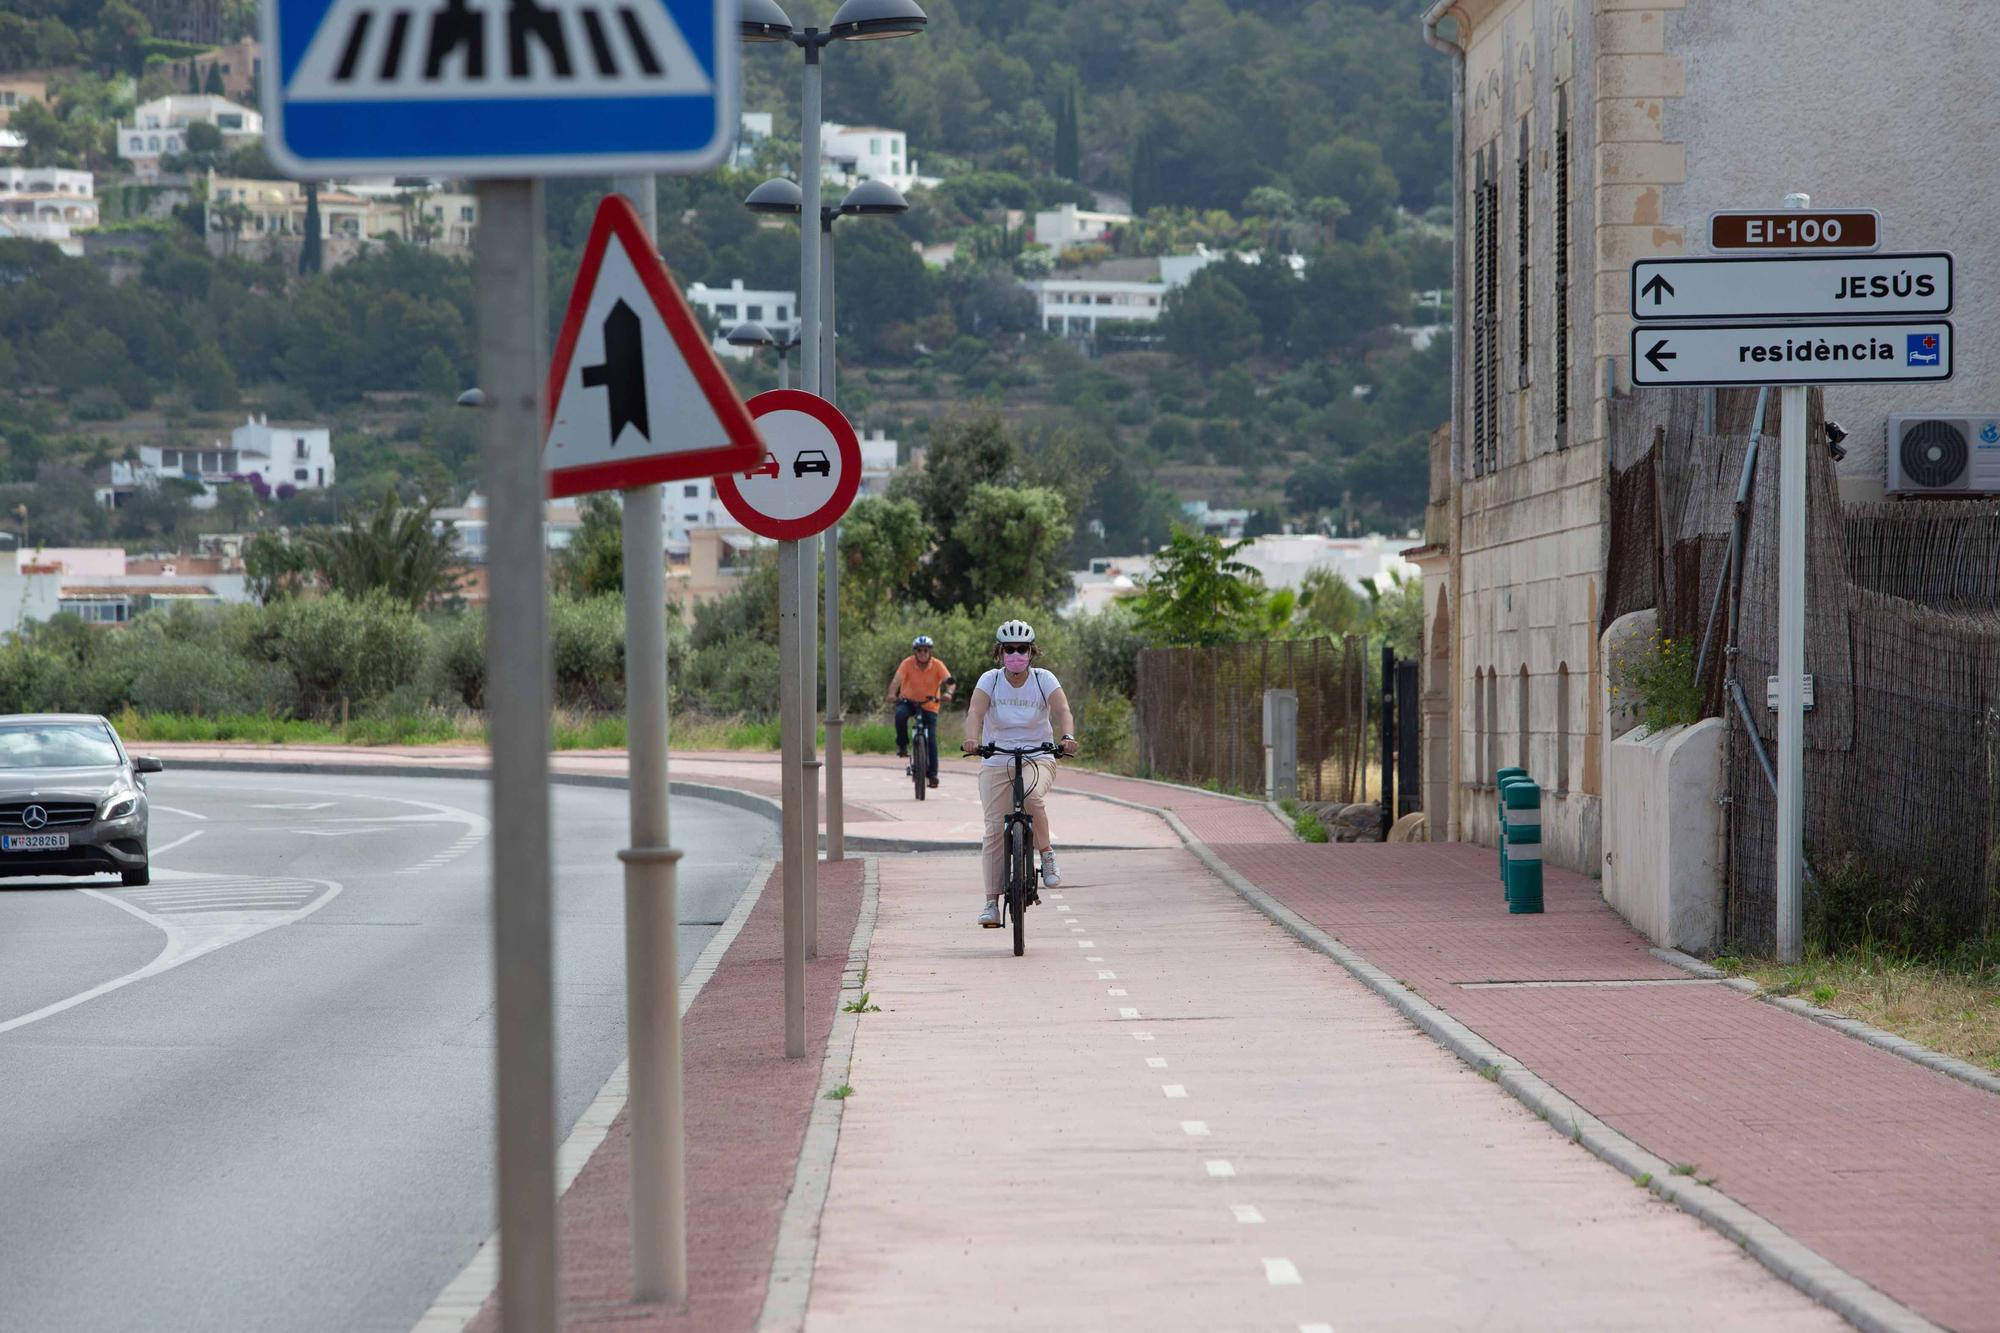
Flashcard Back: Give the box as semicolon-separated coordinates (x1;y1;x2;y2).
0;713;166;885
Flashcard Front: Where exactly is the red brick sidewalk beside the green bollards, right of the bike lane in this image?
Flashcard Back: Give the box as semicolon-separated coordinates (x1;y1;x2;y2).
1072;775;2000;1333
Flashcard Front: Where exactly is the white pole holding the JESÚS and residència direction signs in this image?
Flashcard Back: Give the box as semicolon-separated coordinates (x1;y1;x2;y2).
1776;194;1812;963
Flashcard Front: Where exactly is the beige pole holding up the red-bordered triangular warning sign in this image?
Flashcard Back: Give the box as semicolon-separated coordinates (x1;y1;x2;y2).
612;176;688;1305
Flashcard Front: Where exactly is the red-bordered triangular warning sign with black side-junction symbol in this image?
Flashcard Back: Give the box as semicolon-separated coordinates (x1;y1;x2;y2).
542;194;764;496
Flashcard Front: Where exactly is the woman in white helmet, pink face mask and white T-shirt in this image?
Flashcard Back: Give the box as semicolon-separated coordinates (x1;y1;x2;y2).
960;620;1076;929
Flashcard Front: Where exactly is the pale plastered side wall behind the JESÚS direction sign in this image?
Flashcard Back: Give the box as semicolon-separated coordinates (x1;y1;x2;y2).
1664;0;2000;498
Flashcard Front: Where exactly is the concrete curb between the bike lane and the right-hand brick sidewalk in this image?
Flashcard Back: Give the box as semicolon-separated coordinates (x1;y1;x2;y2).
1112;811;1942;1333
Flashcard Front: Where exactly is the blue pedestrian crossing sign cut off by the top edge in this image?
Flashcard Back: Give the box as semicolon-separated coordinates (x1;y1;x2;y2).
262;0;738;180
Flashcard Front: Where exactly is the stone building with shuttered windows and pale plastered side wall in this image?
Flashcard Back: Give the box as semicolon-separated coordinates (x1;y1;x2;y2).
1412;0;2000;871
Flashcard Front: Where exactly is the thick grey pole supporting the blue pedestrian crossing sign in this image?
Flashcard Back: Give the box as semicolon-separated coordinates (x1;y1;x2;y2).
474;180;558;1333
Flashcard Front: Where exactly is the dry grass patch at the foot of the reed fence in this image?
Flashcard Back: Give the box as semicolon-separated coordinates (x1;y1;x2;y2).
1716;939;2000;1073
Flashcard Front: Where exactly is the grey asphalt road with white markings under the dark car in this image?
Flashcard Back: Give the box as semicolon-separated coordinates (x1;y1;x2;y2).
0;773;776;1333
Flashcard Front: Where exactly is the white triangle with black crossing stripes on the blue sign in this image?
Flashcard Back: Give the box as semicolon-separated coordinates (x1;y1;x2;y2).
284;0;714;102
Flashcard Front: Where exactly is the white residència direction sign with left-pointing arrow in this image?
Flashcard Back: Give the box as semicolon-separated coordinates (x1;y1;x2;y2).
1632;320;1952;386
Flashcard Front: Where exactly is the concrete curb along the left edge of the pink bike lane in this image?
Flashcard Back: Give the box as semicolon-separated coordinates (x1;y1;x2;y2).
756;857;882;1333
